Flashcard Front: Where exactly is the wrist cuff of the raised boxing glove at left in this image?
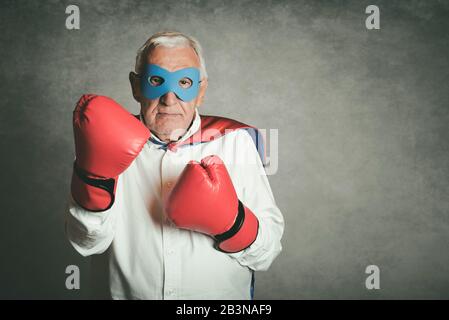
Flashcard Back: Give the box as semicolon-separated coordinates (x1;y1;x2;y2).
71;161;116;212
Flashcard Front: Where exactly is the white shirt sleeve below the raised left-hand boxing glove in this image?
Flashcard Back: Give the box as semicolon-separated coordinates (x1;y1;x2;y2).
65;172;122;257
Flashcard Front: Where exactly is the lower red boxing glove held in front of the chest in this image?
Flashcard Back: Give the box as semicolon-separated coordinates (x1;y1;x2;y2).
166;156;259;253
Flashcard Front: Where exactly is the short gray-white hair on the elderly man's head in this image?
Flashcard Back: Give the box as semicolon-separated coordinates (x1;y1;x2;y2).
135;31;207;79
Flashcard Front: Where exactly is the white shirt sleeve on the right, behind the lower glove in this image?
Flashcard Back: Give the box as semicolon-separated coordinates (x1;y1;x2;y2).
229;130;284;271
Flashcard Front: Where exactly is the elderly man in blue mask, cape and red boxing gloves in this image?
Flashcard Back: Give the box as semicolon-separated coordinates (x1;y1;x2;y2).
66;32;284;299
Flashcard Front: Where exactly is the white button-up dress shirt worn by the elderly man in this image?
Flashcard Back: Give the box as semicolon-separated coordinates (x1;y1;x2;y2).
66;112;284;299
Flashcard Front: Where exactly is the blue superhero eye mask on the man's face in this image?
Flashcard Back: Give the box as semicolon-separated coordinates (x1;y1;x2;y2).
140;64;200;102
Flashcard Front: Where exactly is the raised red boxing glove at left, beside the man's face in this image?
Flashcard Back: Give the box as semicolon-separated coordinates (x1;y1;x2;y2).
71;94;150;211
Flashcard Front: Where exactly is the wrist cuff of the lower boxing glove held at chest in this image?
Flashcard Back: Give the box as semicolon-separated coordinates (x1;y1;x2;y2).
214;200;259;253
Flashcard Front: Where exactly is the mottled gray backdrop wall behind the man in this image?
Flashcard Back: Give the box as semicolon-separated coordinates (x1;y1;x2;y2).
0;0;449;299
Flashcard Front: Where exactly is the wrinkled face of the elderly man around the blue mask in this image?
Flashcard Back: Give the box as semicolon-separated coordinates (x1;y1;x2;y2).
140;46;205;141
